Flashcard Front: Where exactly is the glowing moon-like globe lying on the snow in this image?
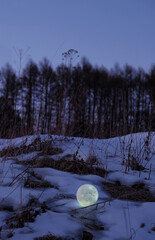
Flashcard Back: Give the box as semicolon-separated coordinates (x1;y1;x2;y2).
76;184;98;207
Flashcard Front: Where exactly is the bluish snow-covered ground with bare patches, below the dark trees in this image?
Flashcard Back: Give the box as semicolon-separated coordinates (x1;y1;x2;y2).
0;133;155;240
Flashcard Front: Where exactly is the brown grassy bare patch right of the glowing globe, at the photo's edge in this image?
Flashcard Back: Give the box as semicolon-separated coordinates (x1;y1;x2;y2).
102;181;155;202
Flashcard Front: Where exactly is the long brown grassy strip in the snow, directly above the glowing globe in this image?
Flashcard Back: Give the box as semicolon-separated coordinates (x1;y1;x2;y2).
20;158;108;177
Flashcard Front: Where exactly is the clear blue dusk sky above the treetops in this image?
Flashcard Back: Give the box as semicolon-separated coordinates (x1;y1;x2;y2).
0;0;155;71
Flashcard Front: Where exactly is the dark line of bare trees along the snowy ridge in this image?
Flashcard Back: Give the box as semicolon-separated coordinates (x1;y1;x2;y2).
0;53;155;138
